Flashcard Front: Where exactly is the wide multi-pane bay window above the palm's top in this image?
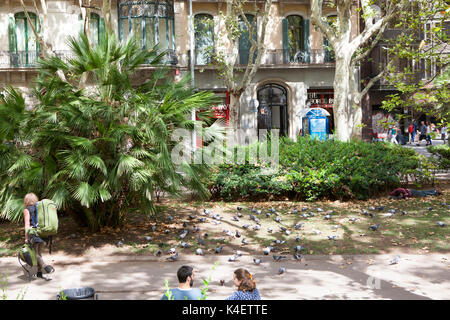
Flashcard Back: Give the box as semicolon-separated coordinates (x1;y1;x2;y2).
119;0;175;51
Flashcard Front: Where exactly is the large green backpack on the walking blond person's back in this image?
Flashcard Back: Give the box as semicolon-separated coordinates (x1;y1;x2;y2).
31;199;58;238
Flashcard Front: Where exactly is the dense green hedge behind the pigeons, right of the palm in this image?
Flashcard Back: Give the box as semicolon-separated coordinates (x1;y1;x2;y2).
209;137;426;201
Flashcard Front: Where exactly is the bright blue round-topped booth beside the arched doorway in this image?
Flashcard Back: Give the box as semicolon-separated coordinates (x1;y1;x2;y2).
302;108;330;141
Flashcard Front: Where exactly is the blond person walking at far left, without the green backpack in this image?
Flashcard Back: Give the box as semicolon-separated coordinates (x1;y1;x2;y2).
23;193;55;280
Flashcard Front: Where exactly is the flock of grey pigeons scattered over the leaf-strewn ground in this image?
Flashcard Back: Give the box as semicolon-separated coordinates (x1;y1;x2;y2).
133;203;446;274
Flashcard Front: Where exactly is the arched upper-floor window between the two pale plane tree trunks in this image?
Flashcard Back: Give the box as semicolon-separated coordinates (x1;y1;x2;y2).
282;15;310;63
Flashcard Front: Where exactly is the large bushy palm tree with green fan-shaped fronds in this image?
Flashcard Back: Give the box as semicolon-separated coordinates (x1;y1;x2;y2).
0;34;220;230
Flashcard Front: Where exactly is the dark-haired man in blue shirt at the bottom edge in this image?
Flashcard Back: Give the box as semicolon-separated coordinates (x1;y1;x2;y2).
161;266;202;300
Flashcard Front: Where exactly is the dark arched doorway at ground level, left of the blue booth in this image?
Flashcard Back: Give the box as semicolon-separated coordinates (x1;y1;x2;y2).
257;83;289;136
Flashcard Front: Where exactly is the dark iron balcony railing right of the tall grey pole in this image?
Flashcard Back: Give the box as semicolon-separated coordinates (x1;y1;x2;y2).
187;49;334;66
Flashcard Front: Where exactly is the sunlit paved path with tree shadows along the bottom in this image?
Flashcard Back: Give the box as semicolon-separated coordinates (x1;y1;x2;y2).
0;253;450;300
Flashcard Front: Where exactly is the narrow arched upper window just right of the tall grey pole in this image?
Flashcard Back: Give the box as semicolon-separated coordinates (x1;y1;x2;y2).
194;14;214;65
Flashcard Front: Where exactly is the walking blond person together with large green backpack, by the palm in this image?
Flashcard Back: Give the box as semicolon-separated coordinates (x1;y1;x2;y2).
23;193;58;280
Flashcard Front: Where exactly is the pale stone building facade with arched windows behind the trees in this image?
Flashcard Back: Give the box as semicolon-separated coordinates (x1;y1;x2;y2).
0;0;358;138
